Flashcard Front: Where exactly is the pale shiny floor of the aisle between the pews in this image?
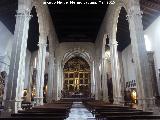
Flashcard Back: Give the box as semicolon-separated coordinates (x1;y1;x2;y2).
66;102;95;120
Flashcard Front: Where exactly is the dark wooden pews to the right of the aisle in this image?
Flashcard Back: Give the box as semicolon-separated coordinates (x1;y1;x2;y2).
83;100;160;120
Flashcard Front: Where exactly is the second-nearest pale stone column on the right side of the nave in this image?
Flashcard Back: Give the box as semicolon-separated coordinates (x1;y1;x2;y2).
110;39;121;104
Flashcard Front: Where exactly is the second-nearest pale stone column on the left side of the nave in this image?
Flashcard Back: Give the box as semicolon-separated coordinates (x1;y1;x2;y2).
35;37;47;105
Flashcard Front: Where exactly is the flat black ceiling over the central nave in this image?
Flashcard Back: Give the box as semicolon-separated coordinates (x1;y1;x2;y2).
47;0;108;43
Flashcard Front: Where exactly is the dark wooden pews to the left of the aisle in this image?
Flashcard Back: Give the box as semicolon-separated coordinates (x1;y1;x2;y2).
0;101;72;120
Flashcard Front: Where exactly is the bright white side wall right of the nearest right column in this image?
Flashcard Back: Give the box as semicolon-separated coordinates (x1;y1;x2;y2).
144;17;160;92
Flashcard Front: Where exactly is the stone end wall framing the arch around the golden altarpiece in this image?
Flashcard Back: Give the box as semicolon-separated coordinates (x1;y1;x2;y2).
55;42;95;97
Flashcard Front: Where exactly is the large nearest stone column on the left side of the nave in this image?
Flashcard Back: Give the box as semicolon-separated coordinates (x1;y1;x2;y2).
5;9;31;113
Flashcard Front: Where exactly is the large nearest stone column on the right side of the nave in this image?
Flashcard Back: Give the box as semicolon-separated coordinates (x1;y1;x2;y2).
127;0;153;109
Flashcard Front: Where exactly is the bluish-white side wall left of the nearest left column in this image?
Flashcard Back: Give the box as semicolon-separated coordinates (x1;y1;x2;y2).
0;21;13;74
